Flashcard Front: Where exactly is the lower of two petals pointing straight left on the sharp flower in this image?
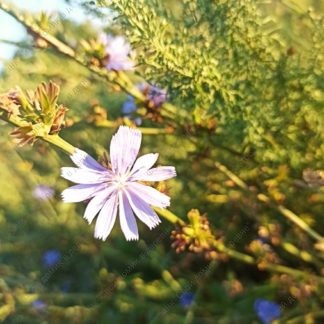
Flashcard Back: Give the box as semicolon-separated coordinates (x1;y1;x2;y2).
61;184;107;202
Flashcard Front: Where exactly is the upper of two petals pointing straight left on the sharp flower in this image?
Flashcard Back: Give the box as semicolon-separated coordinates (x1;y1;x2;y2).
61;167;112;184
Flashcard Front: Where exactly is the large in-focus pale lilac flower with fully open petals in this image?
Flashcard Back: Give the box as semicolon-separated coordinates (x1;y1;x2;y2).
62;126;176;241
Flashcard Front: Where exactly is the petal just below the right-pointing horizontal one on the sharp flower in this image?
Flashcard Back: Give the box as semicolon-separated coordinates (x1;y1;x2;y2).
127;182;170;208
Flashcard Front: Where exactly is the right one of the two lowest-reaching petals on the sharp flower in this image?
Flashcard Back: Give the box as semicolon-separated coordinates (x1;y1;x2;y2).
119;191;138;241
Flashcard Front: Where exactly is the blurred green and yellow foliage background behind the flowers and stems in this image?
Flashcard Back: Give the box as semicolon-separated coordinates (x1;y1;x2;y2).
0;0;324;323
